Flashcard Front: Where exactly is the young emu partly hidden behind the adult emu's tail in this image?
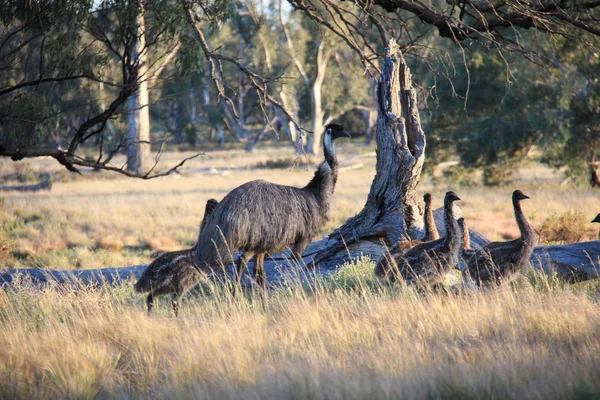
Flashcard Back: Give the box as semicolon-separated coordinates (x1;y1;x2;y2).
133;199;219;317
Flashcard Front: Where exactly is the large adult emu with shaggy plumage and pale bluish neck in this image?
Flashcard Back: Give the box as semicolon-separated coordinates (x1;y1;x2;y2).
196;124;350;293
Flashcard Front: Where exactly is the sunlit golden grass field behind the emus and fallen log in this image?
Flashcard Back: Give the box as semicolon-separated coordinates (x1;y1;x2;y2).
0;146;600;268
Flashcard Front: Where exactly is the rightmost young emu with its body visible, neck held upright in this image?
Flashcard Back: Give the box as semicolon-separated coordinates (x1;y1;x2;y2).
463;190;535;286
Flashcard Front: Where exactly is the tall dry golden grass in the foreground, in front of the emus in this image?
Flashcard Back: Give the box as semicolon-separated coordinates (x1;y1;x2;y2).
0;259;600;399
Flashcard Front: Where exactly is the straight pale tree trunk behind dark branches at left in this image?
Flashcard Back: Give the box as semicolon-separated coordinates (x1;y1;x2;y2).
127;2;150;174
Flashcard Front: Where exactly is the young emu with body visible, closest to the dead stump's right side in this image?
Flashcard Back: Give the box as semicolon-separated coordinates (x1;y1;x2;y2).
375;191;460;286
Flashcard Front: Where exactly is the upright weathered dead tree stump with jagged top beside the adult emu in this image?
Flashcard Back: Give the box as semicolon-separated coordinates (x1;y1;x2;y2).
315;41;425;262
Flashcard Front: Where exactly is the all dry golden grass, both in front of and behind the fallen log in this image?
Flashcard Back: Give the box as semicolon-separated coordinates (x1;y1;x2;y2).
0;146;600;399
